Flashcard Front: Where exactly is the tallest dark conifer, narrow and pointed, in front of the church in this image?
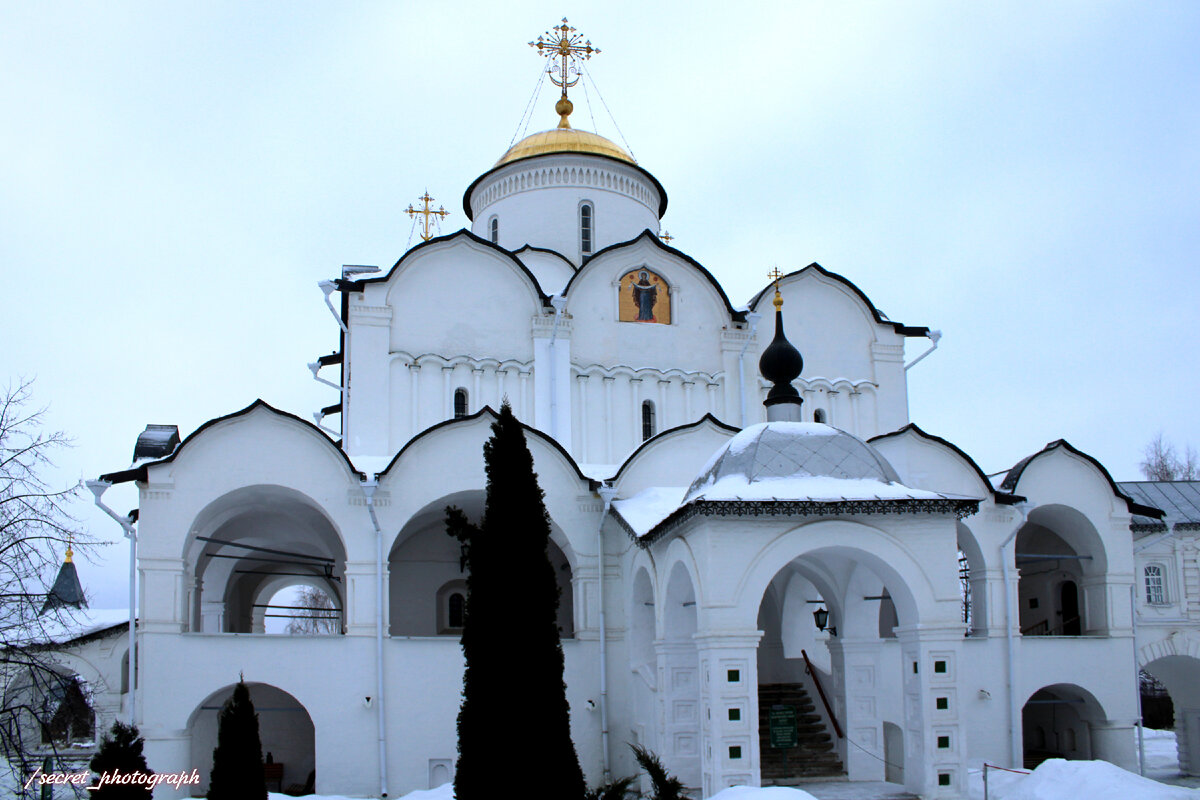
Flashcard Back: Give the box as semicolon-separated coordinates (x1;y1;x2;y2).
446;403;587;800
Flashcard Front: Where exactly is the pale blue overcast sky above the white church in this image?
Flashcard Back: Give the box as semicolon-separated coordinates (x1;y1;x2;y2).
0;0;1200;606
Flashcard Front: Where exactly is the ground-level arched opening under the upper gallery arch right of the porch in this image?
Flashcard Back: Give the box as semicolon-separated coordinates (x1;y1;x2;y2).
1021;684;1109;769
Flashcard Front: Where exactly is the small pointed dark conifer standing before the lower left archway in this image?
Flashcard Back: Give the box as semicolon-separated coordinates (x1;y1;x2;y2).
208;680;266;800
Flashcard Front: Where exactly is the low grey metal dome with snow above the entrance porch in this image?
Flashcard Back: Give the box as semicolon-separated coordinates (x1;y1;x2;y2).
686;422;902;500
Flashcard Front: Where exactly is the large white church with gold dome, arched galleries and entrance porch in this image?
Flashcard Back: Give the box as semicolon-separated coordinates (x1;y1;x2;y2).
44;20;1200;798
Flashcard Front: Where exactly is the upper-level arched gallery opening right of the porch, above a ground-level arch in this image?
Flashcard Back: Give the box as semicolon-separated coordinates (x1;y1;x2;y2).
1016;506;1108;636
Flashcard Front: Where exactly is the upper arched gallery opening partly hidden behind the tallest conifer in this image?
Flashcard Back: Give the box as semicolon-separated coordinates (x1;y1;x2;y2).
388;491;575;638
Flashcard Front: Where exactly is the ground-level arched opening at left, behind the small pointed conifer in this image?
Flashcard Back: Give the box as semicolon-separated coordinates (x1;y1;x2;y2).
187;682;317;795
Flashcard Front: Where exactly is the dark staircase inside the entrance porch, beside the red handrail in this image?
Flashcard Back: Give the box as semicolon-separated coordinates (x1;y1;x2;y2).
758;684;846;786
